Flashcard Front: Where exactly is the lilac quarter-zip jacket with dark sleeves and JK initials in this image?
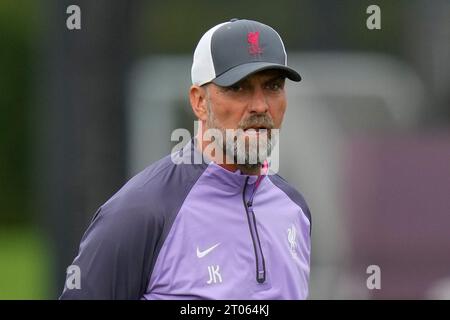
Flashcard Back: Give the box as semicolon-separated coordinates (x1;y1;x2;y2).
60;141;311;299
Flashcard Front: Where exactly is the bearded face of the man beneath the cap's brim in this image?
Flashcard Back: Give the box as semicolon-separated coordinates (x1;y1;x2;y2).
206;70;287;168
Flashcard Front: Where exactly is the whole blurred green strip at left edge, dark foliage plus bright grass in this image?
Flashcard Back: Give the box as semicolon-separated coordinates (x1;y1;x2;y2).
0;1;51;299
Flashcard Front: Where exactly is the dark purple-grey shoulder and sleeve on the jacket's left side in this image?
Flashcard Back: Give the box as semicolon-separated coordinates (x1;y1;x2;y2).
60;151;208;299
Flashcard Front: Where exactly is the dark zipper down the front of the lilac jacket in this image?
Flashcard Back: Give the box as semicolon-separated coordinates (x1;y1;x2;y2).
242;177;266;283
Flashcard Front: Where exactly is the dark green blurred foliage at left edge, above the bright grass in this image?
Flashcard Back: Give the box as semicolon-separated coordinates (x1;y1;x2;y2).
0;0;38;227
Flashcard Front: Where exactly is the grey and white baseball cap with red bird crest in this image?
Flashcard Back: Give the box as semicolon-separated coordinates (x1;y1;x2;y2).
191;19;301;87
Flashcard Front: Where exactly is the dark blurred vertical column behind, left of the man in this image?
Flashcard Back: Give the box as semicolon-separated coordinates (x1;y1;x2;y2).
36;0;137;294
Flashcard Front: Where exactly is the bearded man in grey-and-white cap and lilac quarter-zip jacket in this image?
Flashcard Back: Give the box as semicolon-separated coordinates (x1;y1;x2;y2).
61;19;311;299
